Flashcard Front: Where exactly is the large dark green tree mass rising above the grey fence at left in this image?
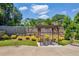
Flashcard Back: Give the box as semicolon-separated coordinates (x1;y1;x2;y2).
0;3;22;26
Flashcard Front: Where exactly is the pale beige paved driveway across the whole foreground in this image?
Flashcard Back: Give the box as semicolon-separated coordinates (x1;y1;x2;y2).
0;46;79;56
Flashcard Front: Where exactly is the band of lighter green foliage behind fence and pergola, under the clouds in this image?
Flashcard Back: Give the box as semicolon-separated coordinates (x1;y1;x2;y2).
22;18;53;27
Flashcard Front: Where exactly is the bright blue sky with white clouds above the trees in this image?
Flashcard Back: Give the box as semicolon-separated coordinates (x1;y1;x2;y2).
14;3;79;19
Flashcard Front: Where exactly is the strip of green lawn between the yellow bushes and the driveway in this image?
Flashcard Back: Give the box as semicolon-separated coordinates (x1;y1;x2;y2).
0;40;37;46
